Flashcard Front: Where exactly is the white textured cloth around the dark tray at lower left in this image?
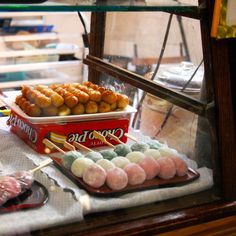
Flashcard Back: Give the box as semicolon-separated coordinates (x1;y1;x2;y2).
0;118;83;236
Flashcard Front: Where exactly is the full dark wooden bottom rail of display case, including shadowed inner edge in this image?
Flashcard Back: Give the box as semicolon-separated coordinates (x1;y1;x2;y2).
32;194;236;236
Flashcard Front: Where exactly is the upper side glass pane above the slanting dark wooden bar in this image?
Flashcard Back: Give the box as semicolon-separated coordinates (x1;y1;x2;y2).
105;12;205;101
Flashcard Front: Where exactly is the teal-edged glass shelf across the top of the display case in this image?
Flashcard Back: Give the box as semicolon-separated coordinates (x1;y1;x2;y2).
0;0;202;18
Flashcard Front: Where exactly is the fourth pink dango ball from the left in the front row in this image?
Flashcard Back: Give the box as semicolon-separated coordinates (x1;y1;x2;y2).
138;156;160;179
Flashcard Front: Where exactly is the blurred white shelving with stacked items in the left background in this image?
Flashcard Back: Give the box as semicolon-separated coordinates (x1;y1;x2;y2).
0;12;89;89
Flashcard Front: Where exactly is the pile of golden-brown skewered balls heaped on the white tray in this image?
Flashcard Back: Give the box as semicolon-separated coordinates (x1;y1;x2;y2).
15;81;129;117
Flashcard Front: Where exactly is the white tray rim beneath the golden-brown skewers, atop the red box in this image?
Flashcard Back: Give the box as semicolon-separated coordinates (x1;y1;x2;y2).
1;97;137;124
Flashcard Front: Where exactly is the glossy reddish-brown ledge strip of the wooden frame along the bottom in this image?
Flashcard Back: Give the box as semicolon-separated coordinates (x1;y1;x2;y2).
81;202;236;236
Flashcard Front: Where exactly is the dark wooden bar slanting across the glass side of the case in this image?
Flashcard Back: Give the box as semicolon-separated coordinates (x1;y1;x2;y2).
84;55;207;116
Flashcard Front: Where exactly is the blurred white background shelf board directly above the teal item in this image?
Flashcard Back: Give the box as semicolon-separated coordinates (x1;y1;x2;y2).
0;60;82;73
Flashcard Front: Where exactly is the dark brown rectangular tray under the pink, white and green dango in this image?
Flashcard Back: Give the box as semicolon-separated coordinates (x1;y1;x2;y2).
51;157;200;197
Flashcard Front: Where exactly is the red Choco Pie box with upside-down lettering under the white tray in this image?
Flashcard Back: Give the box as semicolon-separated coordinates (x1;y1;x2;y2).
7;109;129;154
